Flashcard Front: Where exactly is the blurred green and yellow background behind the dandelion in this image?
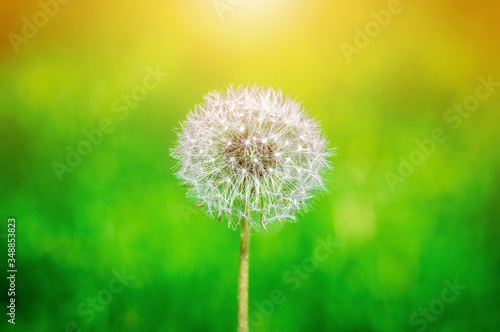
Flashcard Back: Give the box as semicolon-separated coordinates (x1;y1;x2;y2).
0;0;500;332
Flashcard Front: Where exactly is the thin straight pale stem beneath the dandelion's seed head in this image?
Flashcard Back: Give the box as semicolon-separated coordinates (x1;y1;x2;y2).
238;213;251;332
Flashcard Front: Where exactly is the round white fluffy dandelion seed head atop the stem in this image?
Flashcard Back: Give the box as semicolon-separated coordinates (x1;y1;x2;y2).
172;87;330;228
